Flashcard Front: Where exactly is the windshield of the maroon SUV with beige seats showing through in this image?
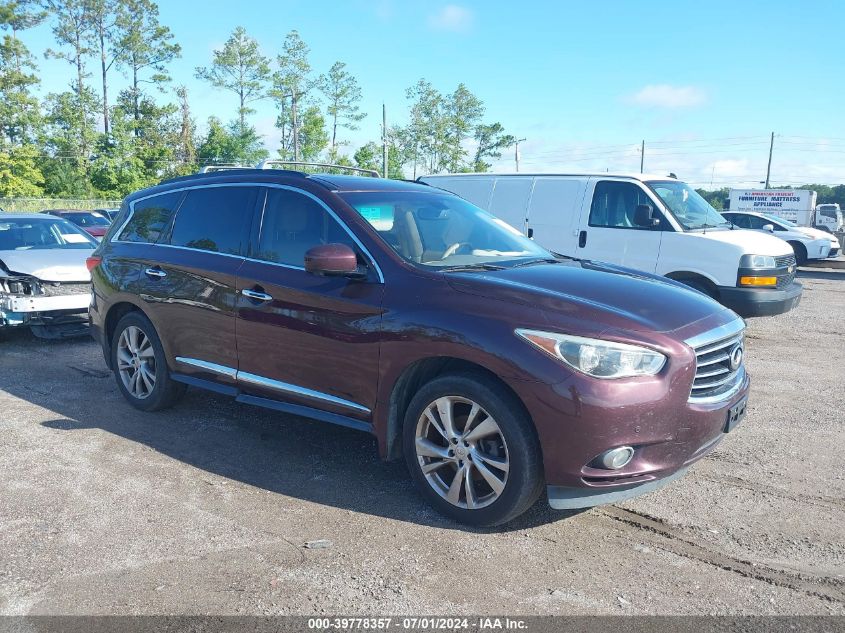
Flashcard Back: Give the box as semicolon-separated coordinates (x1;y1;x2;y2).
340;191;553;267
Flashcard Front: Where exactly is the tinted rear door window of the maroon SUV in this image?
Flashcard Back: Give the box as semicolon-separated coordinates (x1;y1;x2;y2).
170;187;258;255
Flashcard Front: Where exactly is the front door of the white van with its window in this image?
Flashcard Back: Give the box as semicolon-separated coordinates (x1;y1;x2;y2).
577;179;667;273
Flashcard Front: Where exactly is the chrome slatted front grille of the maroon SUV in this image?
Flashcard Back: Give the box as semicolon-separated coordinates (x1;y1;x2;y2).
687;321;745;402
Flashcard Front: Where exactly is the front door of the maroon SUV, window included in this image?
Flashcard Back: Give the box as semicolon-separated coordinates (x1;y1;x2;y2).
237;187;384;421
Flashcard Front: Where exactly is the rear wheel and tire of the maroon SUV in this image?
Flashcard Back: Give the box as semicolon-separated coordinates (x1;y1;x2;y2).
111;312;186;411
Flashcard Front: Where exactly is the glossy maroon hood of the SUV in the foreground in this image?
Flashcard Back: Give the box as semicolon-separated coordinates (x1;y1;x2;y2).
445;260;737;332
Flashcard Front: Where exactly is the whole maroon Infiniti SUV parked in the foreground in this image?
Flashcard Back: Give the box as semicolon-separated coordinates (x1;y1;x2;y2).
89;169;749;525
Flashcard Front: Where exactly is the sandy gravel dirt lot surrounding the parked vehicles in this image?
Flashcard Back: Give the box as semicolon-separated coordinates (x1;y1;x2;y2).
0;272;845;615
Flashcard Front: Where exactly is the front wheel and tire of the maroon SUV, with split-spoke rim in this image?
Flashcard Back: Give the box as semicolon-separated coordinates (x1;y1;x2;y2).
402;374;544;527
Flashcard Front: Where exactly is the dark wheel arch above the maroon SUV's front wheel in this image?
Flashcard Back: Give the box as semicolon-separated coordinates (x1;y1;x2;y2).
381;356;534;460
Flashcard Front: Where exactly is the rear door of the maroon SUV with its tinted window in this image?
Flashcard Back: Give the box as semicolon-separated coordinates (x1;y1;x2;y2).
132;185;258;384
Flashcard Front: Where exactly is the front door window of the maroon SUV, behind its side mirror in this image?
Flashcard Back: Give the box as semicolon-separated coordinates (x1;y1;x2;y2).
252;189;357;268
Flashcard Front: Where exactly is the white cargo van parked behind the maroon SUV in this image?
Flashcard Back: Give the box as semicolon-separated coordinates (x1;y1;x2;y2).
419;174;802;316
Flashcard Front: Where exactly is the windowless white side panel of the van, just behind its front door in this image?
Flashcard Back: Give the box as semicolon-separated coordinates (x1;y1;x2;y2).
527;176;588;256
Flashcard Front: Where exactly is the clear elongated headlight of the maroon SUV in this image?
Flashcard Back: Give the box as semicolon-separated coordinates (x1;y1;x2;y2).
516;329;666;378
